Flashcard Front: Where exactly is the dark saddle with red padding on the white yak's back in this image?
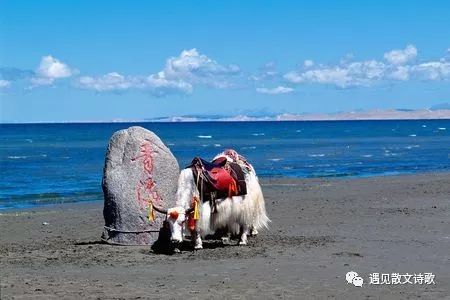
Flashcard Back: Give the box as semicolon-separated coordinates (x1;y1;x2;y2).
188;157;247;202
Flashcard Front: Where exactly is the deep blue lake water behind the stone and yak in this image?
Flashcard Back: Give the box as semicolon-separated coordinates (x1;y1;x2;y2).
0;120;450;209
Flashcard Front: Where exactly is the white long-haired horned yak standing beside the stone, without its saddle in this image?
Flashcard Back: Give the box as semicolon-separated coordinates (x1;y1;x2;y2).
155;150;270;249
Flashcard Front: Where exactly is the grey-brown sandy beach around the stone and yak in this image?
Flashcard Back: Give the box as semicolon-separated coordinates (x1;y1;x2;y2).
0;173;450;299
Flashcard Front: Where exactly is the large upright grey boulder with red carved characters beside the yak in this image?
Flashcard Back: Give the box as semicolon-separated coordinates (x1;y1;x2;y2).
102;126;180;245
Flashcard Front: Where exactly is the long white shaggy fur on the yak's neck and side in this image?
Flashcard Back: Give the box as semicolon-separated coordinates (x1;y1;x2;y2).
177;168;270;236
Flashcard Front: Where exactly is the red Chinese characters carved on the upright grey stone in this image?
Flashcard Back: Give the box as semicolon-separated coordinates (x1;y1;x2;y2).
131;142;163;222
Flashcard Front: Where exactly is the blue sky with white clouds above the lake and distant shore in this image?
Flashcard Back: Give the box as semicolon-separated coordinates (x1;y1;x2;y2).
0;1;450;122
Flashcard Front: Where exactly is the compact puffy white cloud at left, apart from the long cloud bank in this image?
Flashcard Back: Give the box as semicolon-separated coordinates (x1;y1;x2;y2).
31;55;74;87
